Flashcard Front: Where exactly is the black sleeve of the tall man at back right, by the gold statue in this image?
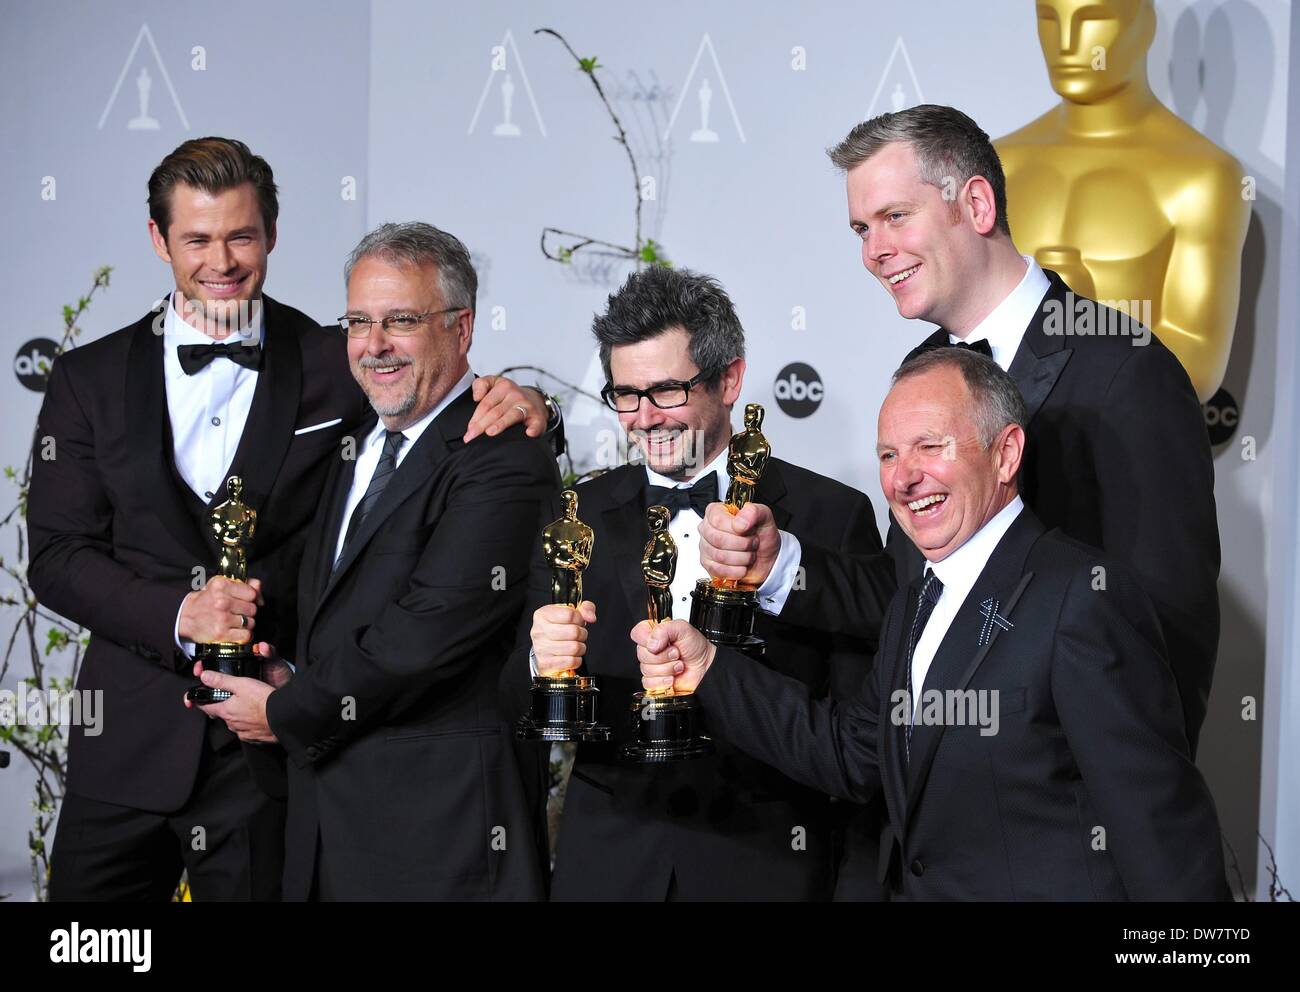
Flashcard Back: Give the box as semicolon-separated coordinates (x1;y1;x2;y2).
1095;346;1219;754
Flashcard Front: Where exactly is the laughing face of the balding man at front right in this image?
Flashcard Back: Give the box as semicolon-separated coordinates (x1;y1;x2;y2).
876;367;1024;562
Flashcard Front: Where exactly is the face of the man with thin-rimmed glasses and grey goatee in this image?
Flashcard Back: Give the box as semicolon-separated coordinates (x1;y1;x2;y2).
347;256;475;430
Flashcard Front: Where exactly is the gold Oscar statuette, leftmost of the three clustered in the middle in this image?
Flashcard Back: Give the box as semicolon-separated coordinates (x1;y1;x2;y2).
515;489;610;741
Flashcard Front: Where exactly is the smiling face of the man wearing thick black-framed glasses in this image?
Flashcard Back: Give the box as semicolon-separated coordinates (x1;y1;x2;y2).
610;328;745;481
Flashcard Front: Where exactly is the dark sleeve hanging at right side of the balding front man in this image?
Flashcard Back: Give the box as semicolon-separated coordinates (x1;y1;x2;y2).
1050;564;1227;901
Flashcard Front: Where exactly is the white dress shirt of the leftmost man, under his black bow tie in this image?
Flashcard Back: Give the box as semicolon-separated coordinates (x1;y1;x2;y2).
163;292;263;503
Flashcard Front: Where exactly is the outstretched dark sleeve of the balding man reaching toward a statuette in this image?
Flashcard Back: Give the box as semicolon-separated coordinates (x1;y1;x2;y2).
696;605;887;803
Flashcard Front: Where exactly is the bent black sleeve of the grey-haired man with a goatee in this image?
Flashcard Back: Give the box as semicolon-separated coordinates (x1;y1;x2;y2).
267;429;555;764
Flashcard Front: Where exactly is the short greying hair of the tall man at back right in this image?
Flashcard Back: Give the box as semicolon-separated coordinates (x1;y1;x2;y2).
826;104;1011;237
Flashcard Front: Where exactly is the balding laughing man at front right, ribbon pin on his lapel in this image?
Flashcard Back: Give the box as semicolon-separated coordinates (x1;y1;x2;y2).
633;348;1227;900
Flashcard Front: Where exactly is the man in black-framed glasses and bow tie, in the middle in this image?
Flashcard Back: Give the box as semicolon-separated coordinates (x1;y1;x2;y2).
504;268;881;901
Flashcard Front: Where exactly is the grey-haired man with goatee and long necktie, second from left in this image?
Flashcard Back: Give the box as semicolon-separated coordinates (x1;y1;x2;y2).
202;224;559;901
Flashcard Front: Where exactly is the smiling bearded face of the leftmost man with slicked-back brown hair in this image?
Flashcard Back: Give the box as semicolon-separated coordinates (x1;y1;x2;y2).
150;182;276;337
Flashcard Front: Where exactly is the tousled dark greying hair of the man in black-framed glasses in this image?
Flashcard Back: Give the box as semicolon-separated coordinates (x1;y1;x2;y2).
592;265;745;382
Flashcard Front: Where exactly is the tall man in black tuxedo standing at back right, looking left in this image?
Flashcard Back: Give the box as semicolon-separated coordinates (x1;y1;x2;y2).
702;105;1219;755
